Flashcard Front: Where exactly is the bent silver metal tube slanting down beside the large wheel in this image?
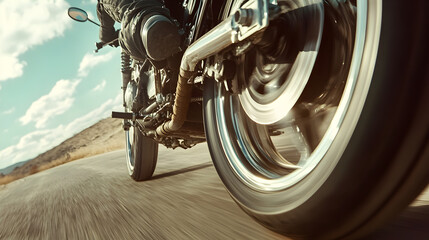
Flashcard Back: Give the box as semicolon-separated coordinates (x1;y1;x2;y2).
156;0;268;136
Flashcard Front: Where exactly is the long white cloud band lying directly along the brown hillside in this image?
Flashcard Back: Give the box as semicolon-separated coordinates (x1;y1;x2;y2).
0;94;122;169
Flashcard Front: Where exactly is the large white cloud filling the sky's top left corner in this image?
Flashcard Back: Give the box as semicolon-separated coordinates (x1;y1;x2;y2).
0;0;71;81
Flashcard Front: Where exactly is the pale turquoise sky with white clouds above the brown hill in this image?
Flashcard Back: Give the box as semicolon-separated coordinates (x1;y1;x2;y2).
0;0;122;169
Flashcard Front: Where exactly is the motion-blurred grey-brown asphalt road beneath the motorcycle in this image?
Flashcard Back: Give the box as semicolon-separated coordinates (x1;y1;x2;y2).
0;144;429;240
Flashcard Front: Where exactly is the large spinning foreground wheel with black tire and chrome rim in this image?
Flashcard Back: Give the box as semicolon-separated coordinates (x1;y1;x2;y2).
204;0;429;239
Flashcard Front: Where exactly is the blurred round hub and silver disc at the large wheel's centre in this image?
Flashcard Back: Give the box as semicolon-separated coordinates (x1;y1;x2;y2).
237;6;323;125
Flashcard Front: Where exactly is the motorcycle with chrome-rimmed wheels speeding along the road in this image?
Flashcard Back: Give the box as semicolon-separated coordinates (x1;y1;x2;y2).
69;0;429;239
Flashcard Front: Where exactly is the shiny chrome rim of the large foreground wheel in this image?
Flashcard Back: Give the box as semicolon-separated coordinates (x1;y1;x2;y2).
214;1;381;191
